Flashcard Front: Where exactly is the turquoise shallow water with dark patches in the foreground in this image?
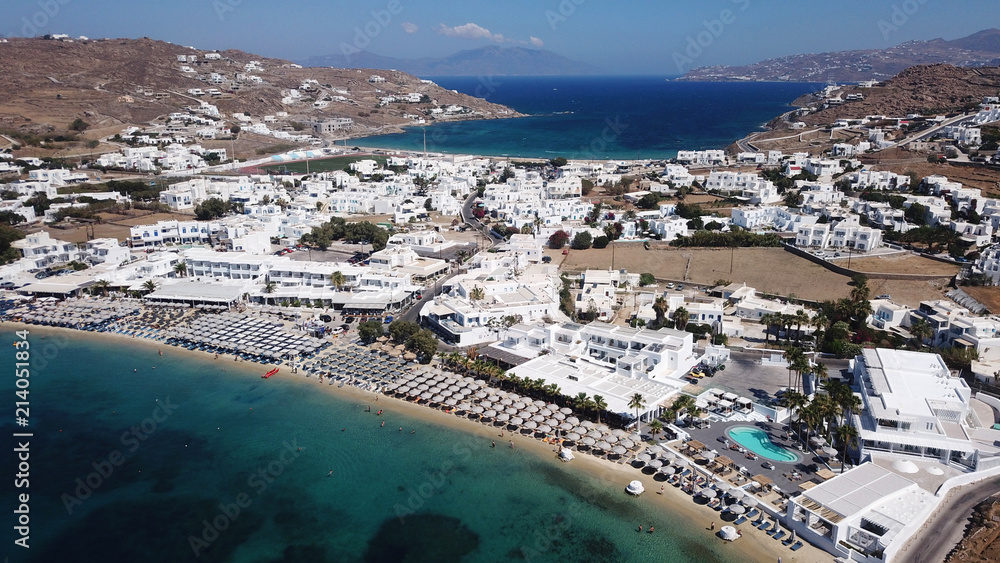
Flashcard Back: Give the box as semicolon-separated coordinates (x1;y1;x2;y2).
0;327;741;563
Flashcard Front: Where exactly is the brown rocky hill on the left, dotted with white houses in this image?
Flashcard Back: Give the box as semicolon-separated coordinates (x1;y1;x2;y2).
0;38;519;142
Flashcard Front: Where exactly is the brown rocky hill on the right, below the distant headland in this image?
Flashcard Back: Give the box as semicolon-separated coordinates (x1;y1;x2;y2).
794;65;1000;124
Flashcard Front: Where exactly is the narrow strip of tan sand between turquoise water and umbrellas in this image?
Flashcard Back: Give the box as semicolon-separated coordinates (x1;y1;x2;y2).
4;322;833;561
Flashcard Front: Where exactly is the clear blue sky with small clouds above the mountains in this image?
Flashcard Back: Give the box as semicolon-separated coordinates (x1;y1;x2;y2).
0;0;1000;75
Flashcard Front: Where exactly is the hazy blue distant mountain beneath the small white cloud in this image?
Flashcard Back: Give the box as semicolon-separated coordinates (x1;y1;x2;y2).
298;45;602;76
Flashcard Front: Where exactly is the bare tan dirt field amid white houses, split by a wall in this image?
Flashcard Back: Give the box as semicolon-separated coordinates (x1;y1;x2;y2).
547;244;947;306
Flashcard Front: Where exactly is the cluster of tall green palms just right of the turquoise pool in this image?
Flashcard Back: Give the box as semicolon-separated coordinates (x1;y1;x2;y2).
780;380;861;472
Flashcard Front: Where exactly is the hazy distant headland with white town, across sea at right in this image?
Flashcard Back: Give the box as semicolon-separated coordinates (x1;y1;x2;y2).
678;29;1000;82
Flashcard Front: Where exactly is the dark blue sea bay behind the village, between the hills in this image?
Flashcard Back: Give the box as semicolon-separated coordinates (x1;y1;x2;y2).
354;76;822;159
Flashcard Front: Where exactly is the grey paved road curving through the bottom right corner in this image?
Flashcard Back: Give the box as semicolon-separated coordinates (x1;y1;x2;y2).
900;477;1000;563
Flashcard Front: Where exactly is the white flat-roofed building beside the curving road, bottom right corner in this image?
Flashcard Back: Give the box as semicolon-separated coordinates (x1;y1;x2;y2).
785;463;937;562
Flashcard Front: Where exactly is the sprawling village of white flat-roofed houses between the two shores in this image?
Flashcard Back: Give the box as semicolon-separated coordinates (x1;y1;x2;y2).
7;41;1000;561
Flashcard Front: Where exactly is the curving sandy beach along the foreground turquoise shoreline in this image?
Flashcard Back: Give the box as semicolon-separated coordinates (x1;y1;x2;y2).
3;323;831;561
